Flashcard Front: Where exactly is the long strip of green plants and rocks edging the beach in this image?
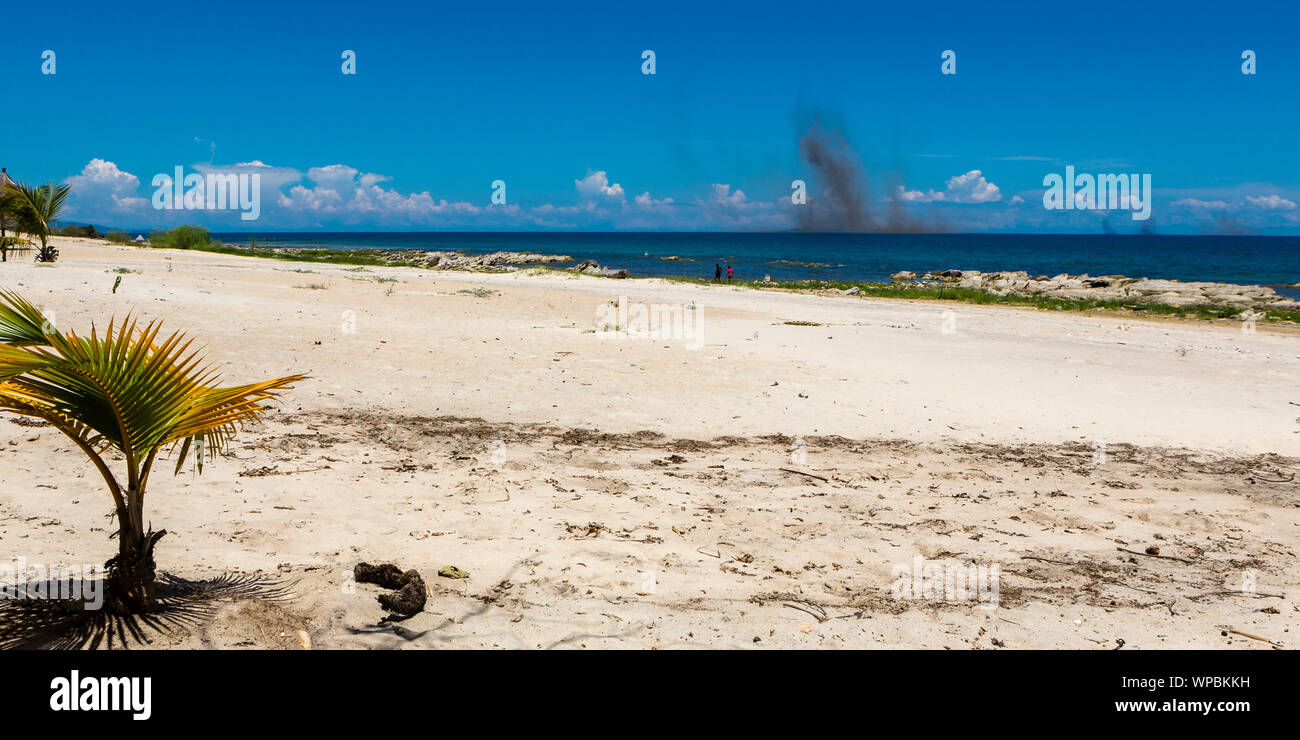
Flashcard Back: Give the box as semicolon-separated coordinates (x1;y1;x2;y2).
91;226;1300;324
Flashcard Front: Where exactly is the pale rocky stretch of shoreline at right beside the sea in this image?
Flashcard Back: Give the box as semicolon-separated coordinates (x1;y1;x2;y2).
889;269;1300;311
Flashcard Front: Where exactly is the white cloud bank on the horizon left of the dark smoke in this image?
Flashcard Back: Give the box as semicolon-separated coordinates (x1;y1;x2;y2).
65;159;792;230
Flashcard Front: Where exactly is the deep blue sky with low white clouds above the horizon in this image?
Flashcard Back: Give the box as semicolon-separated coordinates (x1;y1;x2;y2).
0;0;1300;234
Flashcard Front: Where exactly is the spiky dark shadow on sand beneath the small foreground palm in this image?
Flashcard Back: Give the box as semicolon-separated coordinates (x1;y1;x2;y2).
0;574;291;650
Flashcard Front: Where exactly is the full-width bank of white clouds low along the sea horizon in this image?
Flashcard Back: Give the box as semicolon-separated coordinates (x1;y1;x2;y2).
65;157;1300;234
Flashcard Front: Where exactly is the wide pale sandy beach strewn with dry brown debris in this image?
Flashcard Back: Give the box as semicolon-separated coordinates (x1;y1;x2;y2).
0;238;1300;649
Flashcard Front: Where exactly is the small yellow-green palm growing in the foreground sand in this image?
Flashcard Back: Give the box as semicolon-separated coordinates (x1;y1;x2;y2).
0;291;304;614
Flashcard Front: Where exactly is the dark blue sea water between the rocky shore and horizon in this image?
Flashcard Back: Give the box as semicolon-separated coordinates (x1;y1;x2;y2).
215;231;1300;299
